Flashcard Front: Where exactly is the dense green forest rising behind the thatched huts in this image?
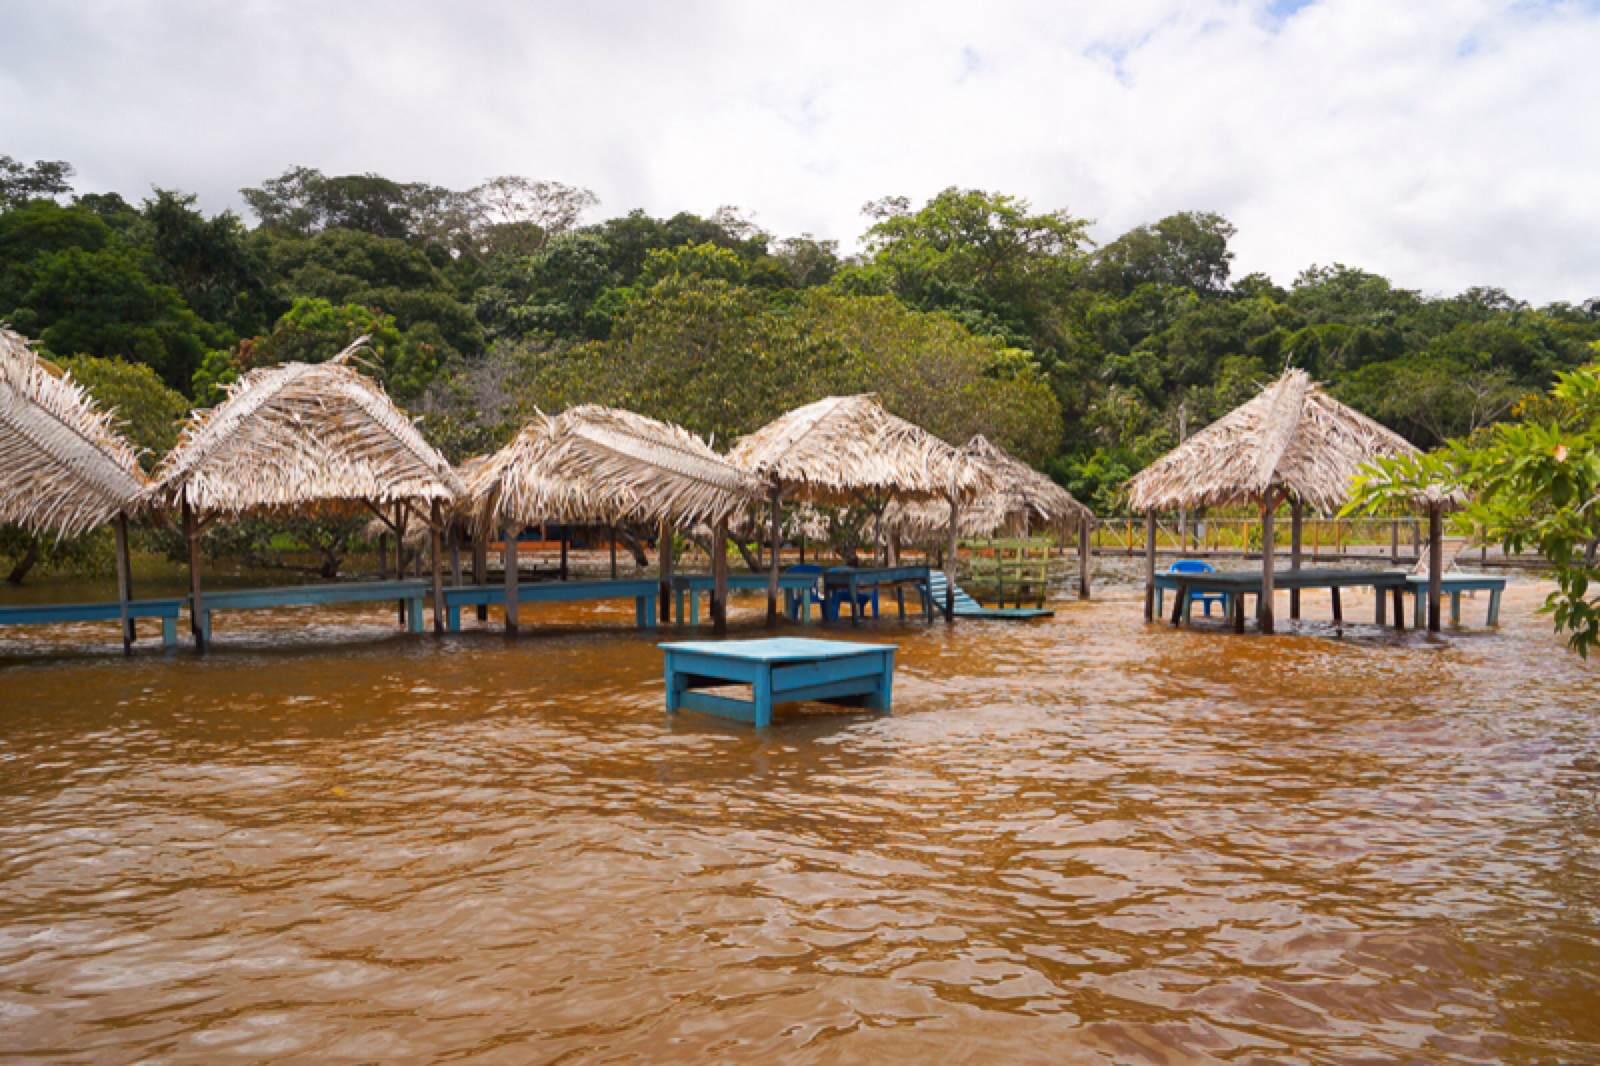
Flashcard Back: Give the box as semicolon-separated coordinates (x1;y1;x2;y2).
9;157;1600;524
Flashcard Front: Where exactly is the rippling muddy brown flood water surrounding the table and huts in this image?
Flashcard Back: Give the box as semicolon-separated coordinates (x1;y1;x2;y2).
0;583;1600;1063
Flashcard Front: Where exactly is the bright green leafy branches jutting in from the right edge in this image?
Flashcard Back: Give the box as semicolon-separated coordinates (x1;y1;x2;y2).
1347;361;1600;656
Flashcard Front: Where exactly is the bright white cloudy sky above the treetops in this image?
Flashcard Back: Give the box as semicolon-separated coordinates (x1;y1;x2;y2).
0;0;1600;303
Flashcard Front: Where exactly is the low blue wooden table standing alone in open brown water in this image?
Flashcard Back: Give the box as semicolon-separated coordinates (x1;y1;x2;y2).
661;637;894;728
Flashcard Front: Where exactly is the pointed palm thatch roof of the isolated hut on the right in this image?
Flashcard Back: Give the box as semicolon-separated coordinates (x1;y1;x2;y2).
1128;368;1416;512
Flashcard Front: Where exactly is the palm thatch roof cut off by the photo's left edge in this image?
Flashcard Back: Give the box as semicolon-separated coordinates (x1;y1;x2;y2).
0;330;149;536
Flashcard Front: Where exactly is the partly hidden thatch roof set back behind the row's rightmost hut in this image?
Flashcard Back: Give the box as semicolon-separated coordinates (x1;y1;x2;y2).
883;434;1094;539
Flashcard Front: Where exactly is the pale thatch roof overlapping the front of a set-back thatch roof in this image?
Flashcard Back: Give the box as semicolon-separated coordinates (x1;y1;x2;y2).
728;394;986;504
